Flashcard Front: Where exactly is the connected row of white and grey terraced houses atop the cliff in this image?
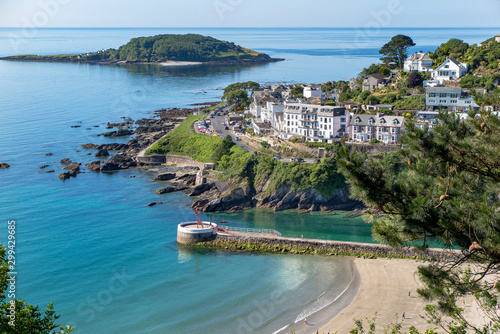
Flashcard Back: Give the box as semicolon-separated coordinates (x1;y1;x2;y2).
250;86;404;144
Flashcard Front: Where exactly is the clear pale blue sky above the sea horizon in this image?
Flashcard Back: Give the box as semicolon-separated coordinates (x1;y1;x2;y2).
0;0;500;28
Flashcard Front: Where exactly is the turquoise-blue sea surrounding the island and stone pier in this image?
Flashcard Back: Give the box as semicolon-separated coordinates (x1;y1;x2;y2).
0;28;499;333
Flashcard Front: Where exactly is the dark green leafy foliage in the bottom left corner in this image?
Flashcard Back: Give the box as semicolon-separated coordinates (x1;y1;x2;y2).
0;245;73;334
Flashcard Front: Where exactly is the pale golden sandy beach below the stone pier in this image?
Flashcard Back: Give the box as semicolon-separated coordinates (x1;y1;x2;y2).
306;258;433;334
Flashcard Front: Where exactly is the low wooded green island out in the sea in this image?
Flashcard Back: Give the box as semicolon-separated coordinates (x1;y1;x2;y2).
0;34;284;66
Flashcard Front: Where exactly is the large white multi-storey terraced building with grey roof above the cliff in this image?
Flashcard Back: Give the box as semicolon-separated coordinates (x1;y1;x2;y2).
282;103;350;143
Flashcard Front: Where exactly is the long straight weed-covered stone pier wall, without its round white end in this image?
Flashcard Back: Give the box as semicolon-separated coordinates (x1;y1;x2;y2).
198;233;461;261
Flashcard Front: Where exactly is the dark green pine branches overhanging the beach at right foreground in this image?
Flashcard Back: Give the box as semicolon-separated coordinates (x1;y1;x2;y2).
339;112;500;333
